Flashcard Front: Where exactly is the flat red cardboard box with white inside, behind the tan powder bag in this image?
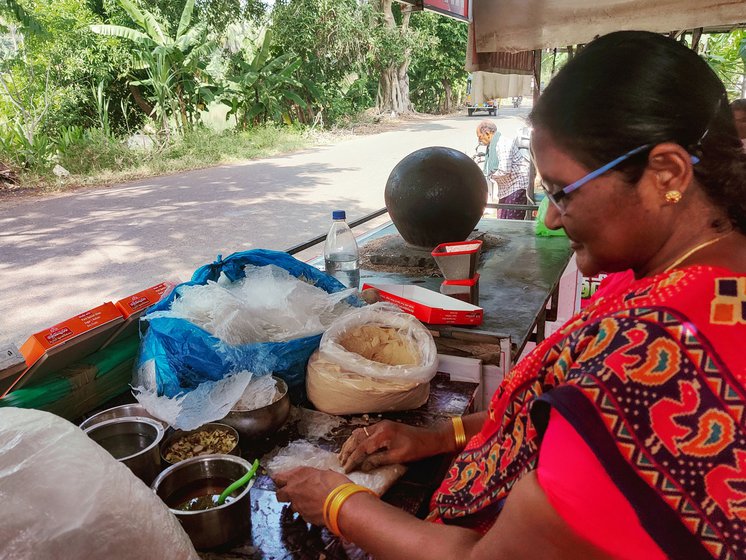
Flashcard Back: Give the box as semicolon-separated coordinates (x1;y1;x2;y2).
363;283;484;325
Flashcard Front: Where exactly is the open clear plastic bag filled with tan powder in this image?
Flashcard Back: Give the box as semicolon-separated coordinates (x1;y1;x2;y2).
306;304;438;414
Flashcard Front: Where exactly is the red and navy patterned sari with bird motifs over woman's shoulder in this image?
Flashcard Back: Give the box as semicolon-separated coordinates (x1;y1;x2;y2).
430;266;746;560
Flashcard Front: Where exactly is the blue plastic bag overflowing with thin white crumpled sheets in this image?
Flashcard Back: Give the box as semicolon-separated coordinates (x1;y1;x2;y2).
132;249;360;430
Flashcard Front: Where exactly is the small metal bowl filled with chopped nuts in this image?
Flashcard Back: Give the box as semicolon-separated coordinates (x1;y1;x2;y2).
161;423;239;465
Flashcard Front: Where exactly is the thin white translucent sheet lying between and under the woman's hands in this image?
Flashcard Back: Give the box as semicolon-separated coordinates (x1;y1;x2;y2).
261;440;407;496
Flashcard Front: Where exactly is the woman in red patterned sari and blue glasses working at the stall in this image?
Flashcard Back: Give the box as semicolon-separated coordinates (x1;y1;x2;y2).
276;32;746;559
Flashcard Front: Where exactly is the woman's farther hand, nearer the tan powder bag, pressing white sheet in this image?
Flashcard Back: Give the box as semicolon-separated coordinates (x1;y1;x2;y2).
339;420;450;472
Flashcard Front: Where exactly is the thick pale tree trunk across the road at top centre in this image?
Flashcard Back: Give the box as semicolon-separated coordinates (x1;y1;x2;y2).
376;0;414;115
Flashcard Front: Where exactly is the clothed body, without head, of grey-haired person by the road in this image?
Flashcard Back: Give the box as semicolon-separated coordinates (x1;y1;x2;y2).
491;127;531;220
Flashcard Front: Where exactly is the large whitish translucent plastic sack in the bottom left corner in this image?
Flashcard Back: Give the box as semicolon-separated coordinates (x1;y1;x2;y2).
0;408;199;560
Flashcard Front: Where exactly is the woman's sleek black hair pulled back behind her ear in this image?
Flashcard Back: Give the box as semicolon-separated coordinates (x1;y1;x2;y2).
530;31;746;231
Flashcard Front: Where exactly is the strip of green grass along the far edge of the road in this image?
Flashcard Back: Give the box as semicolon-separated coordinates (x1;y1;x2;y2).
9;126;321;196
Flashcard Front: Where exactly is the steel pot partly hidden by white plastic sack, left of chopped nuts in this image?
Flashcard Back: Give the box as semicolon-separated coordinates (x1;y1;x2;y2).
85;416;164;484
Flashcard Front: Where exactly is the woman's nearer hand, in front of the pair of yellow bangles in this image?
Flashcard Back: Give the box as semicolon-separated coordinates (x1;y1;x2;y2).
274;467;350;526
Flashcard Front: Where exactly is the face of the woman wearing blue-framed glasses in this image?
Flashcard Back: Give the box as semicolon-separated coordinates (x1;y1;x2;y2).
531;128;665;276
